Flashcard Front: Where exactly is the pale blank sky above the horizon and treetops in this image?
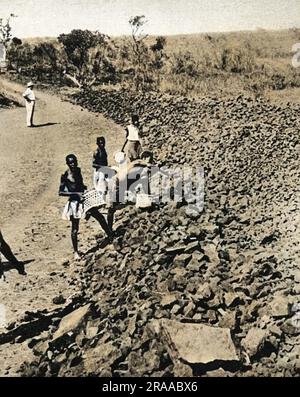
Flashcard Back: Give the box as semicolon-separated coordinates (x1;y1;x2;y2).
0;0;300;38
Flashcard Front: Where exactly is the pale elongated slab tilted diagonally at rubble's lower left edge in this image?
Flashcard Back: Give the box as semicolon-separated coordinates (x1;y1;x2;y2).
52;304;90;341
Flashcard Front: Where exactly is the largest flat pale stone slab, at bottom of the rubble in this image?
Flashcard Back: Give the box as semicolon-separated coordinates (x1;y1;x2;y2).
160;319;239;364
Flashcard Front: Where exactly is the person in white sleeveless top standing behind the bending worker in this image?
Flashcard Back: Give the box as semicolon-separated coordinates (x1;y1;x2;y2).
121;114;142;161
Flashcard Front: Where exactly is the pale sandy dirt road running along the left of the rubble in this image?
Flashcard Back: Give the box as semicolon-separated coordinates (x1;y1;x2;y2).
0;80;123;376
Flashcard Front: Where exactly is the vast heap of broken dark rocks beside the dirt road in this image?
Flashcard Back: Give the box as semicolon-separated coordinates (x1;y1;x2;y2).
24;91;300;376
